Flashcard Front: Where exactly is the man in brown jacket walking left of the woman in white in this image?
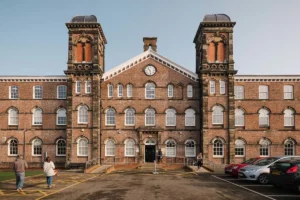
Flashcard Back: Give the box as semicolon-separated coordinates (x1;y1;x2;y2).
13;155;28;192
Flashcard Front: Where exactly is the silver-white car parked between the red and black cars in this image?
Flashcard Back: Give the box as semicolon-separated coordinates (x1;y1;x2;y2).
238;156;300;184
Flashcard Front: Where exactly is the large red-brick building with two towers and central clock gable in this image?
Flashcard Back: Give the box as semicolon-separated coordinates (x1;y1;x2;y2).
0;14;300;167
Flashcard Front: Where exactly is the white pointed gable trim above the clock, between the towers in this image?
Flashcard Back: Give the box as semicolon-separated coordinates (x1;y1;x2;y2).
103;49;199;81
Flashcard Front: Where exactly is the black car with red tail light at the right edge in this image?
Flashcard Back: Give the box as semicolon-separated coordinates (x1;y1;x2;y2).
268;159;300;193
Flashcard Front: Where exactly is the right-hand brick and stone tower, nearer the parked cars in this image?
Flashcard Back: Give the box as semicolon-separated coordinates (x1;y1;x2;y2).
194;14;237;163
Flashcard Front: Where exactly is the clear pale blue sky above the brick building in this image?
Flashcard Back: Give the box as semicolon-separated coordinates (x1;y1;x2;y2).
0;0;300;76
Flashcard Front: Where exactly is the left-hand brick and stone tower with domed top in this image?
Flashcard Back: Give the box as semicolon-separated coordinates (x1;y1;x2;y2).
65;15;106;166
